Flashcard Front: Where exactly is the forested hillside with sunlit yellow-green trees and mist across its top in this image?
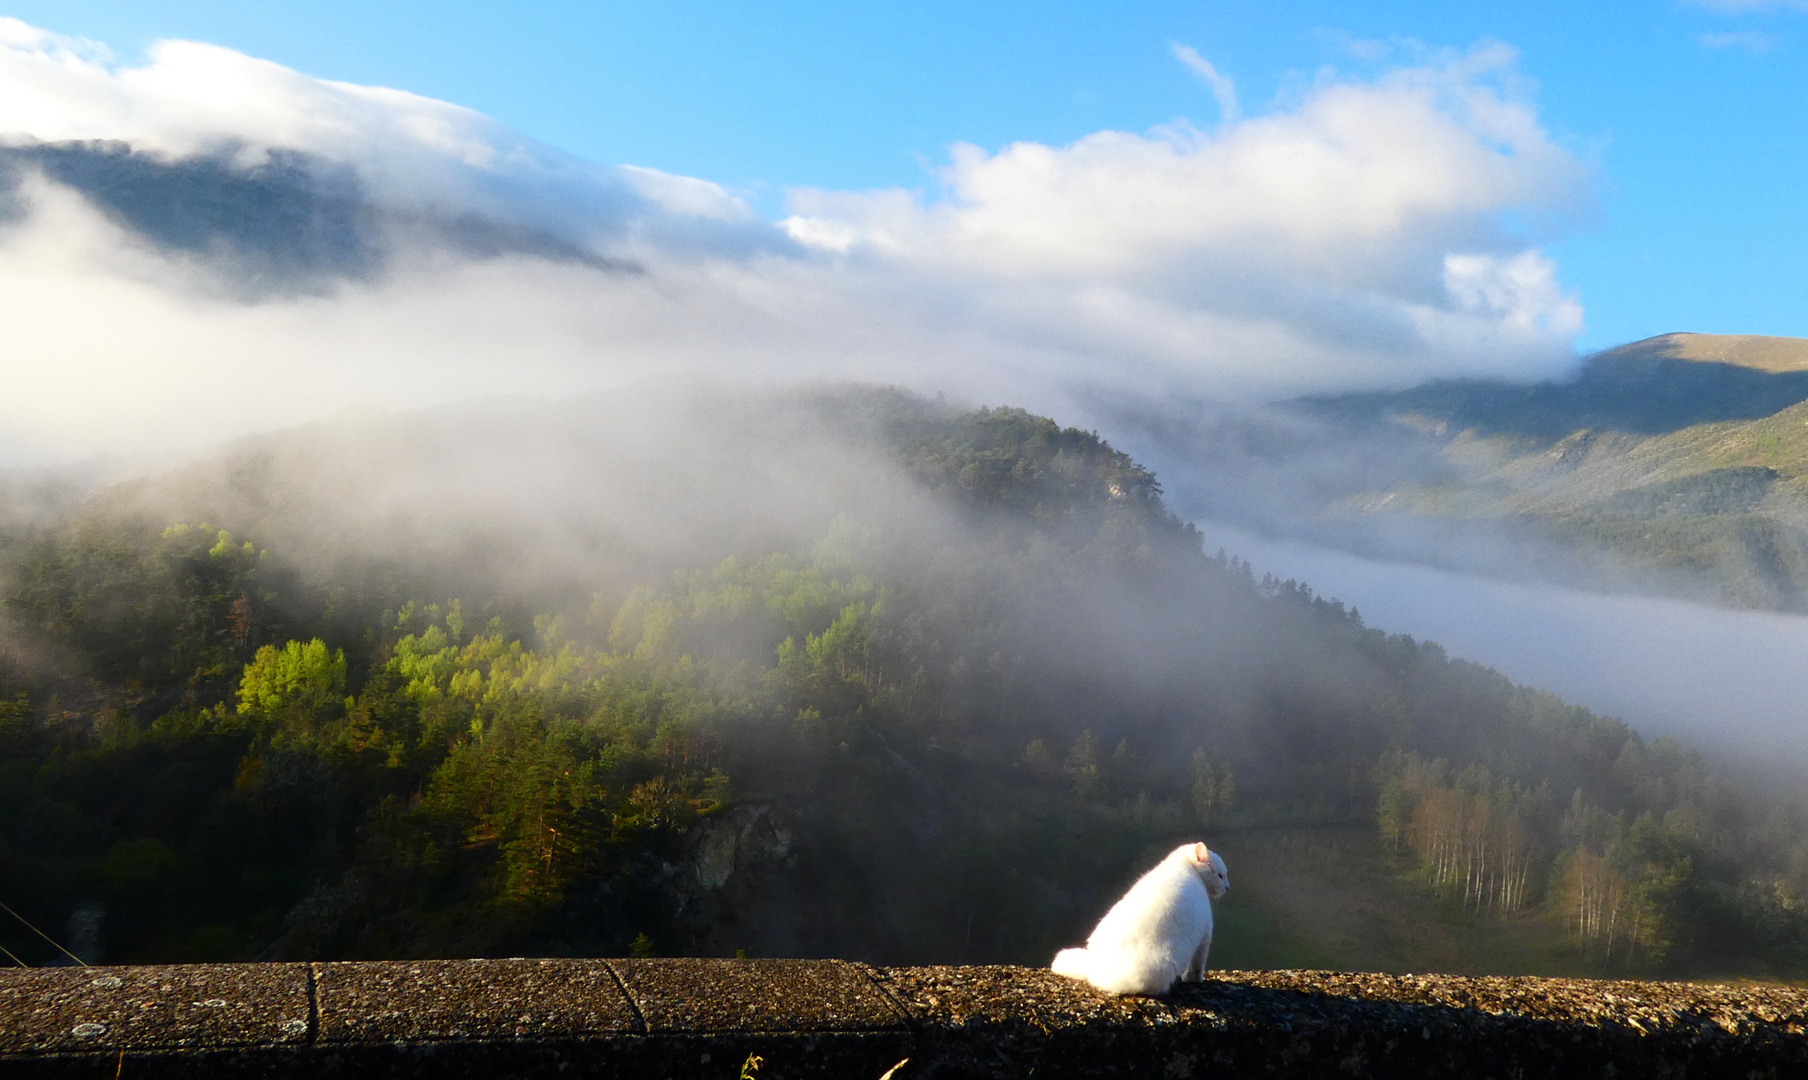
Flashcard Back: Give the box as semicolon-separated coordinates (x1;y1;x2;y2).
0;389;1808;975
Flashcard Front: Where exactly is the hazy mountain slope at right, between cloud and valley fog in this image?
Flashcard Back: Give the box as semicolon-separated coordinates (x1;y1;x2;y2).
1154;333;1808;611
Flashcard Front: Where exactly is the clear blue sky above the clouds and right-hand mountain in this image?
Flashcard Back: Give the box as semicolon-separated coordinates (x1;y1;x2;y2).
7;0;1808;347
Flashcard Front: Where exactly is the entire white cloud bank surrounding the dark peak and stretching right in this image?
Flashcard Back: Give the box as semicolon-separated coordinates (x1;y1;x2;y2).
0;22;1589;459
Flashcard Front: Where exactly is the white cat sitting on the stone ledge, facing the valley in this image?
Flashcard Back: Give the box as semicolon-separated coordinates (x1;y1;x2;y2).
1050;843;1231;995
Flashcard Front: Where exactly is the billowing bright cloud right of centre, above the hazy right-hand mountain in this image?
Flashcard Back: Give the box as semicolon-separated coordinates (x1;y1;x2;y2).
788;47;1587;393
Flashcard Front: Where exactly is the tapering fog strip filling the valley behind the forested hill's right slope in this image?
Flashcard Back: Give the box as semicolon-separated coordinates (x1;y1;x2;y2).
1197;521;1808;769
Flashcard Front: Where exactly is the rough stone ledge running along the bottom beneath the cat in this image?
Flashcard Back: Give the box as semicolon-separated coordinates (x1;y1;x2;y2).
0;959;1808;1080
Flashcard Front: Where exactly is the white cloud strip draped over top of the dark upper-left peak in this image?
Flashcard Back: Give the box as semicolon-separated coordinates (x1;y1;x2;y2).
0;20;770;255
